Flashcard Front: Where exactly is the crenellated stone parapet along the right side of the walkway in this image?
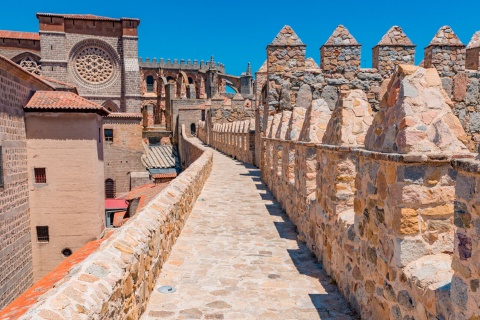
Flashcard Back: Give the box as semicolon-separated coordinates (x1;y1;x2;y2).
202;65;480;319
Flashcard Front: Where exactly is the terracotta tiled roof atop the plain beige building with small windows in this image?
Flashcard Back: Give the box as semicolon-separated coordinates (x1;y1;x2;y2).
24;91;110;114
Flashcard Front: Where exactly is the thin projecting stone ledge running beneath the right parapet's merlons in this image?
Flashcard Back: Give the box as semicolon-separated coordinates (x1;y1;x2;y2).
262;138;474;164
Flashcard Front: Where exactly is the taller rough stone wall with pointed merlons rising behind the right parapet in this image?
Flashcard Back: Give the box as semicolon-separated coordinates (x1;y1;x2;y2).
255;26;480;151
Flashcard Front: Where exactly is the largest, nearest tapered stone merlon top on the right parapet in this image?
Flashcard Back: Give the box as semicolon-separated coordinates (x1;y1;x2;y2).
365;65;468;154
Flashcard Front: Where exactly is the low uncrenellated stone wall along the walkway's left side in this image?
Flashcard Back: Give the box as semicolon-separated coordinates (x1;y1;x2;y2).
8;129;213;319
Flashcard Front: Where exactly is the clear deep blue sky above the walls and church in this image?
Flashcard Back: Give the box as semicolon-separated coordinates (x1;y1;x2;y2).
0;0;480;74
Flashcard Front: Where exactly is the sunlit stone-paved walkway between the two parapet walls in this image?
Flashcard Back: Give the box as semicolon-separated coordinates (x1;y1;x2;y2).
141;152;356;320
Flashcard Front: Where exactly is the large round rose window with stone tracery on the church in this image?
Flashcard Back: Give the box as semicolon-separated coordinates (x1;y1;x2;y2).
75;47;114;84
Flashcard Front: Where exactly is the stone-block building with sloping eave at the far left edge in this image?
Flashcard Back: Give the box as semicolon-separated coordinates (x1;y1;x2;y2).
0;56;53;308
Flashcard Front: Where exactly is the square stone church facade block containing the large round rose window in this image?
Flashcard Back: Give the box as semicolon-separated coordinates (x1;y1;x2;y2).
37;13;141;112
